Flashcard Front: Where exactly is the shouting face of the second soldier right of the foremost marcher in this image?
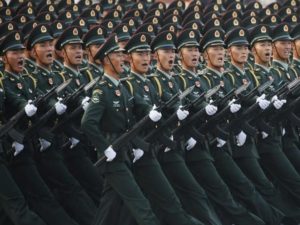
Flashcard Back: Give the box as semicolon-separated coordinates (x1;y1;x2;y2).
156;49;175;71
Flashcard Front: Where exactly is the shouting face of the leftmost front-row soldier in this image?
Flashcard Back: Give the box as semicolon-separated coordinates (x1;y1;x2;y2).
3;50;25;73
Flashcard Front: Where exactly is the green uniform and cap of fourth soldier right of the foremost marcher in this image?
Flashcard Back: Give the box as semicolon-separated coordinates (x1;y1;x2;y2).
200;29;283;224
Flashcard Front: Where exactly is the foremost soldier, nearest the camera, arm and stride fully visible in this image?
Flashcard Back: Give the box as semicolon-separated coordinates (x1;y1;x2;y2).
82;34;161;225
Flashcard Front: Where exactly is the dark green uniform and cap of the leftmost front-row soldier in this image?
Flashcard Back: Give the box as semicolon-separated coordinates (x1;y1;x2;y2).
0;32;77;225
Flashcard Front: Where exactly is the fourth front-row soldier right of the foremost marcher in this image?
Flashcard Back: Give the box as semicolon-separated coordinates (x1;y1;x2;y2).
200;28;282;224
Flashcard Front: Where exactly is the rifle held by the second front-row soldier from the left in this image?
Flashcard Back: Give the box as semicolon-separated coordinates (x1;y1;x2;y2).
25;78;99;136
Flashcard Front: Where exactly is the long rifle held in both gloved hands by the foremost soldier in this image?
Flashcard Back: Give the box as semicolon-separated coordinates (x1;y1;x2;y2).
94;86;194;167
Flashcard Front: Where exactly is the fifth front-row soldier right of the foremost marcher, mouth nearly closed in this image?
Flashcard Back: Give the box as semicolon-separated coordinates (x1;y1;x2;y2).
224;27;300;223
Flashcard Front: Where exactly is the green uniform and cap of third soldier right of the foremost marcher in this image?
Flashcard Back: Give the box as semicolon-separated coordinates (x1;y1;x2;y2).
176;27;270;224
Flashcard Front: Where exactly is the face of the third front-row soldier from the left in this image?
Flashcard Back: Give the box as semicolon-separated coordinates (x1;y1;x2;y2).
63;44;83;66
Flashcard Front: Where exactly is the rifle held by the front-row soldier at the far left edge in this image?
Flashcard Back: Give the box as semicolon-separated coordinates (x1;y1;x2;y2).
0;79;71;139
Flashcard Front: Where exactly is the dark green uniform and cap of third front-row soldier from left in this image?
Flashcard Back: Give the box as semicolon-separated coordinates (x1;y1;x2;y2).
56;27;102;207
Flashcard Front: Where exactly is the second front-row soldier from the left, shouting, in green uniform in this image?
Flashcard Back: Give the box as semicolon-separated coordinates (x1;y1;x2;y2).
26;24;95;224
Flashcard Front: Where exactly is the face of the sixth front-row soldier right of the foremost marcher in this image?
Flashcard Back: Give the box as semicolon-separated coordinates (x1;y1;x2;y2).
252;41;272;63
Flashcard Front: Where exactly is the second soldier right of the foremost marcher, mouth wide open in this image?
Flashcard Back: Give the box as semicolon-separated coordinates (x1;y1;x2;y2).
149;31;220;224
